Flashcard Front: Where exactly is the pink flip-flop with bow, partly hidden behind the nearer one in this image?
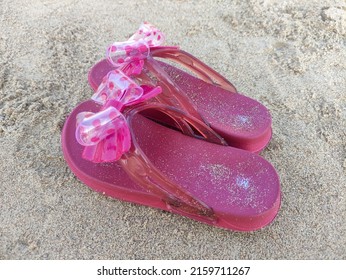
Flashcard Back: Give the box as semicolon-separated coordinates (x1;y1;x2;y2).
89;23;272;152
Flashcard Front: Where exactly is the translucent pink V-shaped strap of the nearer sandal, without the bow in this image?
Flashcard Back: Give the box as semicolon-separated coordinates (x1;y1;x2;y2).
118;103;227;221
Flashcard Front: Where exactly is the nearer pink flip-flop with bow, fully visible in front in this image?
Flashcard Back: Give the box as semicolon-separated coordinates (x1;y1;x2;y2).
61;67;280;231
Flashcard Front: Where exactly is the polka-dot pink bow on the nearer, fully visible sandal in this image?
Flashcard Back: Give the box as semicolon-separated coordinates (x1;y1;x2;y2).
76;69;162;163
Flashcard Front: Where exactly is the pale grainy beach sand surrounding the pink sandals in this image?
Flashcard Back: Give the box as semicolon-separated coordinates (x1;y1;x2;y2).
0;0;346;259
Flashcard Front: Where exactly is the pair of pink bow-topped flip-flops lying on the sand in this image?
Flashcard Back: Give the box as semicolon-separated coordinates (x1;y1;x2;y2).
62;23;281;231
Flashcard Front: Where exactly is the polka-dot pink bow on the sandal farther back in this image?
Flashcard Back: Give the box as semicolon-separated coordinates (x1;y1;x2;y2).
106;22;165;75
